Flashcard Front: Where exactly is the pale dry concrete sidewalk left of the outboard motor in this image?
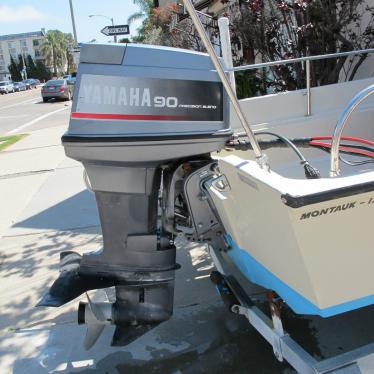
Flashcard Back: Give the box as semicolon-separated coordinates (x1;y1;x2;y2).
0;127;96;331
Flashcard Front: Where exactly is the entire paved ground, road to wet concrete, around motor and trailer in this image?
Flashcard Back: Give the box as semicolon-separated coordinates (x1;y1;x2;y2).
0;89;374;374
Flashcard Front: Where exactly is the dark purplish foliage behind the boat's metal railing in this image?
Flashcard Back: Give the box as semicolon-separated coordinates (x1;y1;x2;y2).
228;0;374;90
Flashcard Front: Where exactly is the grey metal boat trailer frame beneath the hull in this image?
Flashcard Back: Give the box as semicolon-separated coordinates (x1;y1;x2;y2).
209;247;374;374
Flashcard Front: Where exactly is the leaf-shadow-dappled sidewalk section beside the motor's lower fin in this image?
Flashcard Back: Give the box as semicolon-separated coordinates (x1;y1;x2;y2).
0;228;102;331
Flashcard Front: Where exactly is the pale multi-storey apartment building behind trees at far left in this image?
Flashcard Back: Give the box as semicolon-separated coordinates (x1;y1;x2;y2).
0;29;45;80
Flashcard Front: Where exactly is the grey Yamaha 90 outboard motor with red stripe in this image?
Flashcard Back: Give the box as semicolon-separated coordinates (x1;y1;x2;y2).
39;44;231;347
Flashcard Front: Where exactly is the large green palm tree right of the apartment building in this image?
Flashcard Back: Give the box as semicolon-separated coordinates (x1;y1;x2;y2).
41;30;67;76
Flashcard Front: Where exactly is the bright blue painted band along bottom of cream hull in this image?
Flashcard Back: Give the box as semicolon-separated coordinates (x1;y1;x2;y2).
226;235;374;317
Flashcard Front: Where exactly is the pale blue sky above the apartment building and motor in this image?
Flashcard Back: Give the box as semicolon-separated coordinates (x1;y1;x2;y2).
0;0;141;43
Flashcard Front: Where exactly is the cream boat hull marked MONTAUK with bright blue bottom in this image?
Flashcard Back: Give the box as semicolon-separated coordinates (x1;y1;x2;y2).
208;156;374;317
